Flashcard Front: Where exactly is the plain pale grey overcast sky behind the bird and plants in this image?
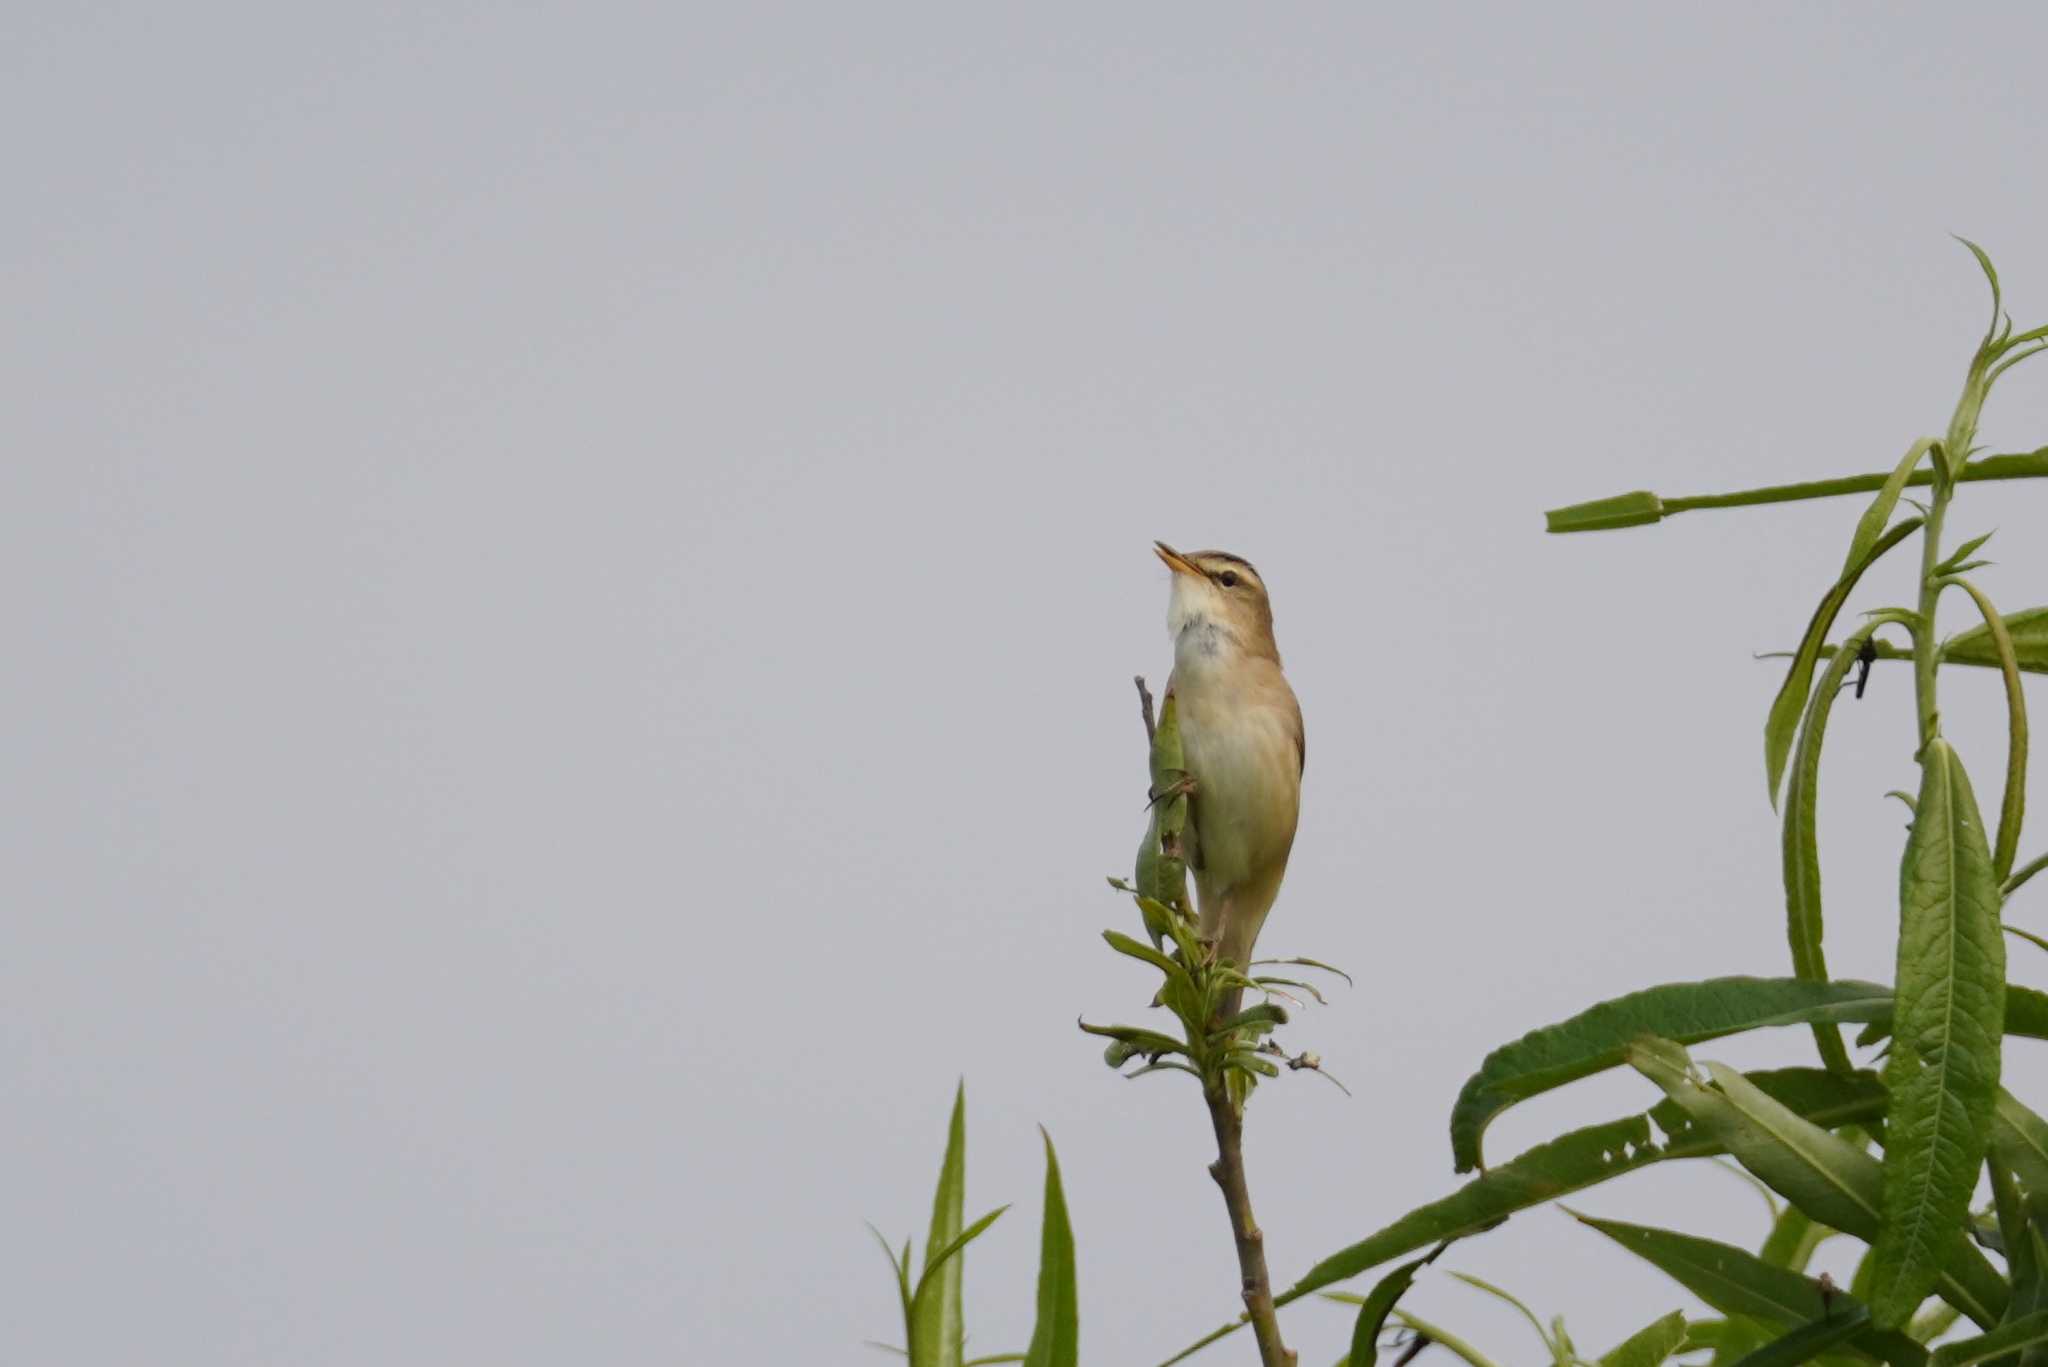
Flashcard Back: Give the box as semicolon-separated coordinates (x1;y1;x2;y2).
12;4;2048;1367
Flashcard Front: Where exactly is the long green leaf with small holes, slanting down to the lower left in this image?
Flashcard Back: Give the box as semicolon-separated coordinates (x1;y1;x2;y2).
1274;1068;1884;1306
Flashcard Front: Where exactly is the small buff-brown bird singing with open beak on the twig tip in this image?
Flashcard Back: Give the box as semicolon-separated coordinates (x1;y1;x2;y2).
1153;541;1309;969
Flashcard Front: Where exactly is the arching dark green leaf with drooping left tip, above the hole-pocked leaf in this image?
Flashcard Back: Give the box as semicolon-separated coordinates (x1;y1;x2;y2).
1450;978;1892;1172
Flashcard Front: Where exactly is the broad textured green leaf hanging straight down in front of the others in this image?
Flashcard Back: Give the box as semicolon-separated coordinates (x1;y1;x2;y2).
1870;736;2005;1328
